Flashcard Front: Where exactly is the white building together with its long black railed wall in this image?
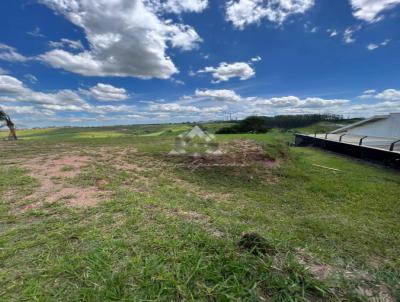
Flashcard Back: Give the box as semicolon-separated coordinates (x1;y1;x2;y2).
295;113;400;168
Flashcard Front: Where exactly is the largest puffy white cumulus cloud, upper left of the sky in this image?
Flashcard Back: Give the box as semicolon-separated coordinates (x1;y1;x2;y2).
40;0;203;79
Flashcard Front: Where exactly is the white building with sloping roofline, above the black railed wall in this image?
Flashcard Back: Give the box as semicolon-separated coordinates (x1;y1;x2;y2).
331;113;400;139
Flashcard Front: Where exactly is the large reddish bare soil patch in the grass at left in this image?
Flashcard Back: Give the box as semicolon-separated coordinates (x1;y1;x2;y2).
6;148;142;211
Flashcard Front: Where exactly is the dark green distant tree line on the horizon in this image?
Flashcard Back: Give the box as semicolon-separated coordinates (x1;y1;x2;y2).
217;114;344;134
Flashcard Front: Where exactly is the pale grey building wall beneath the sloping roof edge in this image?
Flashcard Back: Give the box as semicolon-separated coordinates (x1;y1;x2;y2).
347;113;400;139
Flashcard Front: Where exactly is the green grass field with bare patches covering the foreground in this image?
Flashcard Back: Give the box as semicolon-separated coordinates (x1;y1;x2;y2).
0;124;400;301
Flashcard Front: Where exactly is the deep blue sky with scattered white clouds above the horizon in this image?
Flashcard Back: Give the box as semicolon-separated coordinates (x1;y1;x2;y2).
0;0;400;127
